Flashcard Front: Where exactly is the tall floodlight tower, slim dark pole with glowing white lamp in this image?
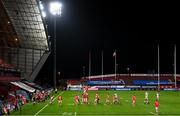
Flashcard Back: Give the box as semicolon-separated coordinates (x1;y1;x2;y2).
50;1;62;89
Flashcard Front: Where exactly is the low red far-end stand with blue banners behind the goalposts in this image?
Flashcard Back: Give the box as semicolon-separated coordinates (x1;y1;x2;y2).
65;74;180;91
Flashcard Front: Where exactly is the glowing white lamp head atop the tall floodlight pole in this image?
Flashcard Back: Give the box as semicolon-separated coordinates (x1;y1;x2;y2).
50;1;62;15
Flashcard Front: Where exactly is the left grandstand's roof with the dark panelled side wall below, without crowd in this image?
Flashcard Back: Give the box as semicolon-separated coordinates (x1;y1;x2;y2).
0;0;50;81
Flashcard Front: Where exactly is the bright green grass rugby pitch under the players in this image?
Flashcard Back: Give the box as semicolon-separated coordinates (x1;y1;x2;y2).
11;91;180;116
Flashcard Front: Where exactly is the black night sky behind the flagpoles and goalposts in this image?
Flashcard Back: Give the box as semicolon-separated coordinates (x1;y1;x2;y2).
36;0;180;81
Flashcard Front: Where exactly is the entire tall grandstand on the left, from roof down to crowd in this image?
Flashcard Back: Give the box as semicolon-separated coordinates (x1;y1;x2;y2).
0;0;52;115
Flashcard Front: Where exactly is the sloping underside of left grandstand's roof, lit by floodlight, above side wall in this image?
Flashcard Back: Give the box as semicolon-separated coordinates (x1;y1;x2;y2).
0;0;49;50
